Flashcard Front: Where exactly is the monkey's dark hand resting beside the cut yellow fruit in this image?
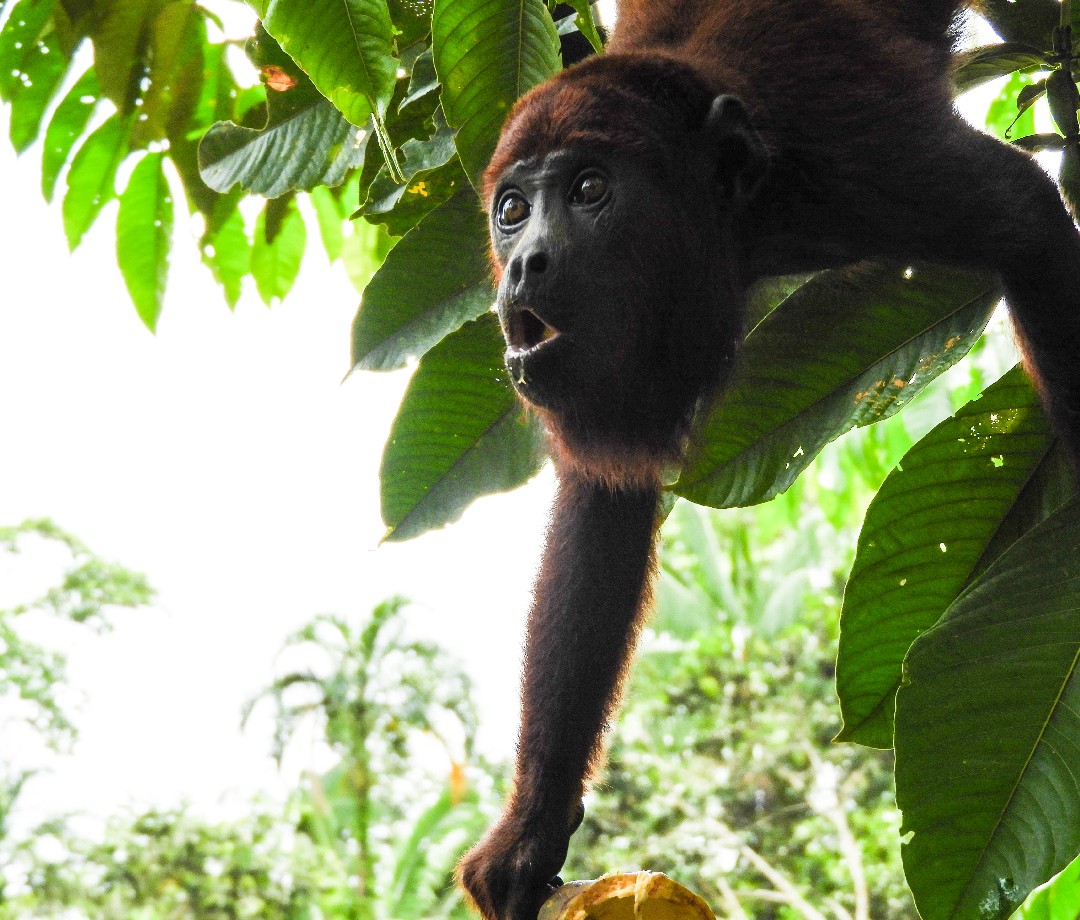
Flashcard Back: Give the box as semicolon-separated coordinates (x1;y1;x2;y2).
458;806;584;920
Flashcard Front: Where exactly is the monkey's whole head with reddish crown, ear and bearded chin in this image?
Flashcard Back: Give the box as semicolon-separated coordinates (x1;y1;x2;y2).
485;55;766;484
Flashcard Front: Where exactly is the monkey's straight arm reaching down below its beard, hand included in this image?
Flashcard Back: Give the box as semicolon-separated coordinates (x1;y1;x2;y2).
459;471;659;920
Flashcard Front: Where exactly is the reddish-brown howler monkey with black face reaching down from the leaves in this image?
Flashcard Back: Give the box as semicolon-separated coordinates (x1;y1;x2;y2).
460;0;1080;920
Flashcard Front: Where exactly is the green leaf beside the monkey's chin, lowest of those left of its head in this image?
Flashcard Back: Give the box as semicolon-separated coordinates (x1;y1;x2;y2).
380;313;544;541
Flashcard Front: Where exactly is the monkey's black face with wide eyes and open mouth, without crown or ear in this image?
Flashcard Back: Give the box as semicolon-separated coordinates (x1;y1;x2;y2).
490;148;741;470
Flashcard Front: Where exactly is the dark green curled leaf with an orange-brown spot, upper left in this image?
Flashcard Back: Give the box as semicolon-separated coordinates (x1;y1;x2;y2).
199;29;366;198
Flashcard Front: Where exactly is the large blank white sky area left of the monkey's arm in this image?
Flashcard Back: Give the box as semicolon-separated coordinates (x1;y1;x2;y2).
0;113;552;820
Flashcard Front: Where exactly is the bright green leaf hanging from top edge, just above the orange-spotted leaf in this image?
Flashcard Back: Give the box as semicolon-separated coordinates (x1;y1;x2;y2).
264;0;397;127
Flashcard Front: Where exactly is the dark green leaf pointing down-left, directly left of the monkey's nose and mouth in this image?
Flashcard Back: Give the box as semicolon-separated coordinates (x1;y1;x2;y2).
352;187;495;370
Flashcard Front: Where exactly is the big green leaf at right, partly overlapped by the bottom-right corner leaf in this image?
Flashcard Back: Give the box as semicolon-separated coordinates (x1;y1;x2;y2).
836;367;1053;747
